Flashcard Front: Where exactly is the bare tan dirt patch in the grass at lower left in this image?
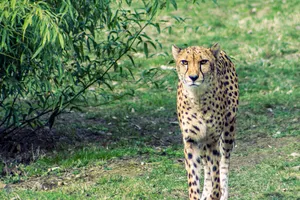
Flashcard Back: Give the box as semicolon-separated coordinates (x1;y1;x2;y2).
6;158;152;191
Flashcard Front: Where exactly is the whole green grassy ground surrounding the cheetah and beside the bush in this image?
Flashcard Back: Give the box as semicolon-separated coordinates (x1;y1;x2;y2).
0;0;300;200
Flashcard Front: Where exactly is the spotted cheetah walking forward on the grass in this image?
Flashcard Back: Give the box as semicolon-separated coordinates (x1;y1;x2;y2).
172;44;239;200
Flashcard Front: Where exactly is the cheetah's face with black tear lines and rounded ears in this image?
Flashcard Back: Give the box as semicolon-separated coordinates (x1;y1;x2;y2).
172;44;220;88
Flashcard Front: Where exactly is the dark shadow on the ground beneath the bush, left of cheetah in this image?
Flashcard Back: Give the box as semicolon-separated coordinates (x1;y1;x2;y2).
0;107;181;168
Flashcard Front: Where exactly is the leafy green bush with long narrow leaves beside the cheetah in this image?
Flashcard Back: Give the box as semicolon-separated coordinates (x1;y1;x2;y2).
0;0;180;137
